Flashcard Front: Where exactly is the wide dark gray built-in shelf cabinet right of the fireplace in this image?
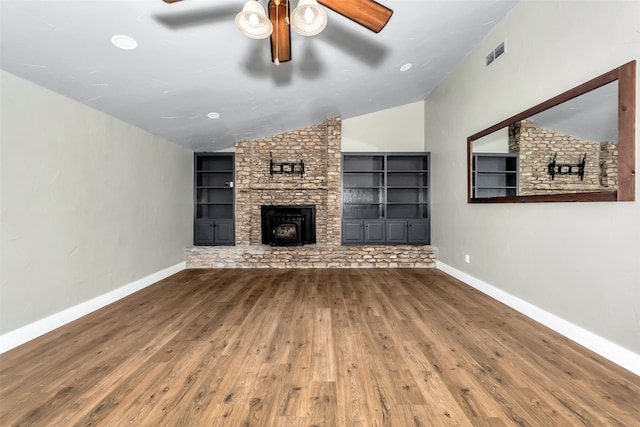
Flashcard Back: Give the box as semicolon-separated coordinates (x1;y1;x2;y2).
342;153;430;245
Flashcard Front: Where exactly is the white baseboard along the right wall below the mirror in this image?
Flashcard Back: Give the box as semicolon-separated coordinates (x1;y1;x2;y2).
436;261;640;375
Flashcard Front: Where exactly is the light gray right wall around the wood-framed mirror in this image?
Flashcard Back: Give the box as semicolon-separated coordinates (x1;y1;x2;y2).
425;1;640;353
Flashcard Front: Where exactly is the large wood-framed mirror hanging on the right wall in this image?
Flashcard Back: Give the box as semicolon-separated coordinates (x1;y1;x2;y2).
467;61;636;203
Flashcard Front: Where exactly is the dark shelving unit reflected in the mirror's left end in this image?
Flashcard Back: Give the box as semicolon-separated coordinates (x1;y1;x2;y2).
472;153;519;198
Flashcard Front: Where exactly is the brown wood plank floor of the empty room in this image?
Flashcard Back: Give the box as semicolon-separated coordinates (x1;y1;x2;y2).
0;269;640;427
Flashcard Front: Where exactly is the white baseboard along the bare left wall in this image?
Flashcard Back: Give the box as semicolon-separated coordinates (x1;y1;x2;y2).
0;262;186;354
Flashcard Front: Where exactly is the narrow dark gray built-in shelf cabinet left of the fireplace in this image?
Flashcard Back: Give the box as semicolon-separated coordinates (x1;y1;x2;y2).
193;153;235;246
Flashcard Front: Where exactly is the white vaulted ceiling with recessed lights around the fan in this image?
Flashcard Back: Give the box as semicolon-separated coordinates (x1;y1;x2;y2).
0;0;517;151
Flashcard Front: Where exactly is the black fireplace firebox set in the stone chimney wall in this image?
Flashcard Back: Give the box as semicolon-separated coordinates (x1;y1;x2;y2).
261;205;316;246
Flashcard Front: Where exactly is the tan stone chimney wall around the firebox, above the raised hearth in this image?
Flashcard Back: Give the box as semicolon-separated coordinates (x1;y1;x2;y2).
235;117;342;245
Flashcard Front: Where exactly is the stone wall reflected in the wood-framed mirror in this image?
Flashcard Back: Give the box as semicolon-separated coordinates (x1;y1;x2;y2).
509;119;618;196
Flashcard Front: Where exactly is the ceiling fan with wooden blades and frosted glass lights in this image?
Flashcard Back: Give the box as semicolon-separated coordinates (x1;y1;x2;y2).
163;0;393;65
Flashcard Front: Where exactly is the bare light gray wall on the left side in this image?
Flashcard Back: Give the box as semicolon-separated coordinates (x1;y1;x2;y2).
0;71;193;334
